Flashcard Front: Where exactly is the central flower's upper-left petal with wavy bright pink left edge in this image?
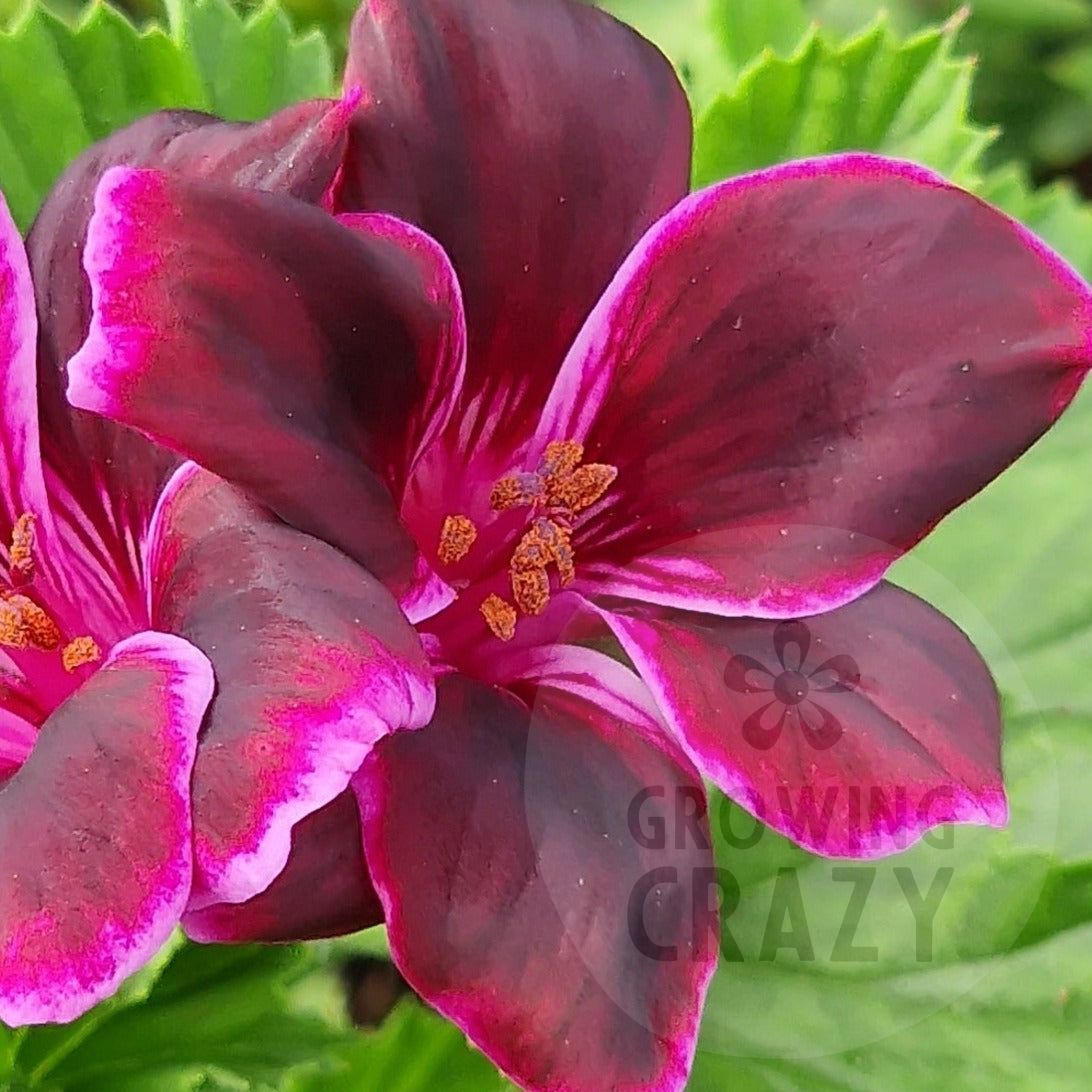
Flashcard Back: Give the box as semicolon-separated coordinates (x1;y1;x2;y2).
69;168;464;607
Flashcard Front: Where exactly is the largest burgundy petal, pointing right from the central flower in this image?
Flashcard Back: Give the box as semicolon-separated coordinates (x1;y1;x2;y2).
532;155;1092;617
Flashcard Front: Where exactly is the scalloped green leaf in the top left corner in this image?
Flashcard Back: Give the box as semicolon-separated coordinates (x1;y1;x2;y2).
0;0;333;227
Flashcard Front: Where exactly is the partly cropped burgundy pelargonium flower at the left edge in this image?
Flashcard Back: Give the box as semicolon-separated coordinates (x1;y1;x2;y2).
0;103;432;1024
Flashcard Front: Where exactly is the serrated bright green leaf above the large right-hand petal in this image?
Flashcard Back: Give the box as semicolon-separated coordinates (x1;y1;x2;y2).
695;20;994;186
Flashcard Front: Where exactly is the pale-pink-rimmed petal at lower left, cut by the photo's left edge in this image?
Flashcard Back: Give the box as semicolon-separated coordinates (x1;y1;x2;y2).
0;633;213;1024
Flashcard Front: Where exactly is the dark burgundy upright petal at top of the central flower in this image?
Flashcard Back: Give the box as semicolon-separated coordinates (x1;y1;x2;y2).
337;0;691;456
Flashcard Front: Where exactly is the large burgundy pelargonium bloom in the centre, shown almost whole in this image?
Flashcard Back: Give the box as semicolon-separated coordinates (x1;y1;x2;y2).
69;0;1092;1089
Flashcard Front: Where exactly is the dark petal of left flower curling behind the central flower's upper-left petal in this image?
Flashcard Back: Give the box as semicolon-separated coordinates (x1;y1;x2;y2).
27;98;356;603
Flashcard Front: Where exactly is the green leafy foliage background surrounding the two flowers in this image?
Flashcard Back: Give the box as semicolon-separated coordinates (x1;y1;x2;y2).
0;0;1092;1092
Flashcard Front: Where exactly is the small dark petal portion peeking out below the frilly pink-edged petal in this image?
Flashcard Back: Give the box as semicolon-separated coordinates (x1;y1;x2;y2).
181;790;383;943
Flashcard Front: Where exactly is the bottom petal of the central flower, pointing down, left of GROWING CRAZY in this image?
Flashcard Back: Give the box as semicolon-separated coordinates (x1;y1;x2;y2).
354;676;716;1092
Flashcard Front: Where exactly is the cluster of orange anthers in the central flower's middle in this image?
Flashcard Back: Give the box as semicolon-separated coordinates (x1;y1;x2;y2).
437;440;618;641
